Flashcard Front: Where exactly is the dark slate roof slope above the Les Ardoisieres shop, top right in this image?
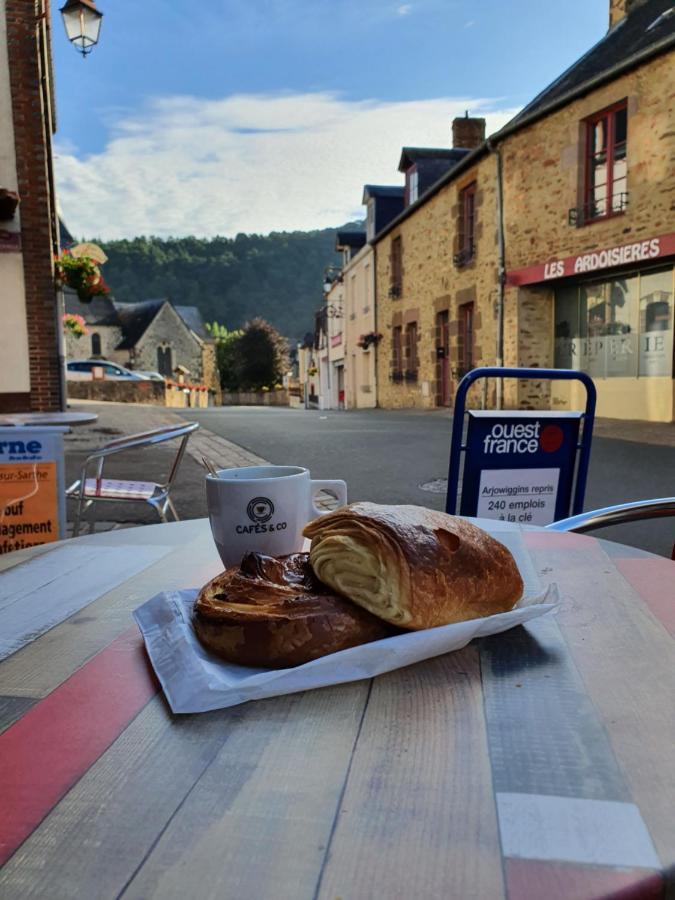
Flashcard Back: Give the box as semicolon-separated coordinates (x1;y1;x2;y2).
504;0;675;130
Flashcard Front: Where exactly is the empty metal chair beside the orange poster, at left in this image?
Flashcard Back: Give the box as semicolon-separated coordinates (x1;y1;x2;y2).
66;422;199;537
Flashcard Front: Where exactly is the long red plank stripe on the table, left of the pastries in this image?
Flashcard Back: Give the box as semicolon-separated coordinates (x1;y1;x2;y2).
0;628;158;865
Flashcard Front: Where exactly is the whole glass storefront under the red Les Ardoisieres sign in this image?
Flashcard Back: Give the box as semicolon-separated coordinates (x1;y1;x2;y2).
555;266;675;378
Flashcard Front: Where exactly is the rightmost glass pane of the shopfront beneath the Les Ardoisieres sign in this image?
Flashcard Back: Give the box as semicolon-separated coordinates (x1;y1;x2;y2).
640;269;673;377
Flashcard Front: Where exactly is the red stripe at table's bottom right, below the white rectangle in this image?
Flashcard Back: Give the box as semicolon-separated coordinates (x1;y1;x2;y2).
505;859;664;900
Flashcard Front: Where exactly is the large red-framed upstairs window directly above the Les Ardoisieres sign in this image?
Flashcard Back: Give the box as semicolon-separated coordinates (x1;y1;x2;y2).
584;101;628;221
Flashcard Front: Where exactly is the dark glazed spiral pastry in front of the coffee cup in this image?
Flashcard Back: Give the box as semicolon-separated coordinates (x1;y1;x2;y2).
193;553;394;669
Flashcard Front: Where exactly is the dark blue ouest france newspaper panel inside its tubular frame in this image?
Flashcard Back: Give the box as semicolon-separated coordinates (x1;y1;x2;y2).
460;410;582;525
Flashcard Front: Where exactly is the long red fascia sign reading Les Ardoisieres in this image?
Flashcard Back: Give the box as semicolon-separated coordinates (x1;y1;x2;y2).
506;232;675;287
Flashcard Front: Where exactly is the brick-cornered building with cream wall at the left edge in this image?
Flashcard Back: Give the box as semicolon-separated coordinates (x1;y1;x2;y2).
0;0;64;412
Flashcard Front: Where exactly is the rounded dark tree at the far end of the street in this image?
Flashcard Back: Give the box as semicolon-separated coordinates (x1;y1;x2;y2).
234;318;288;391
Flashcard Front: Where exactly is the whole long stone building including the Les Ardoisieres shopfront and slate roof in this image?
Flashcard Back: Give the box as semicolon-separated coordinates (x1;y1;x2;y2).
373;0;675;421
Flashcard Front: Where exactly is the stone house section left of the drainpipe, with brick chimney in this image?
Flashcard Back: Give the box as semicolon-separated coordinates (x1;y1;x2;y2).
373;117;496;408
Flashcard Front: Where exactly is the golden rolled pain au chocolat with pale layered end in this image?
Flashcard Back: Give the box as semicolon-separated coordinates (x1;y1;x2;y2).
304;503;523;629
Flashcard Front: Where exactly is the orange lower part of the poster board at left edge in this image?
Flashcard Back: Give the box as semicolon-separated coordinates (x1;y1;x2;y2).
0;461;59;553
